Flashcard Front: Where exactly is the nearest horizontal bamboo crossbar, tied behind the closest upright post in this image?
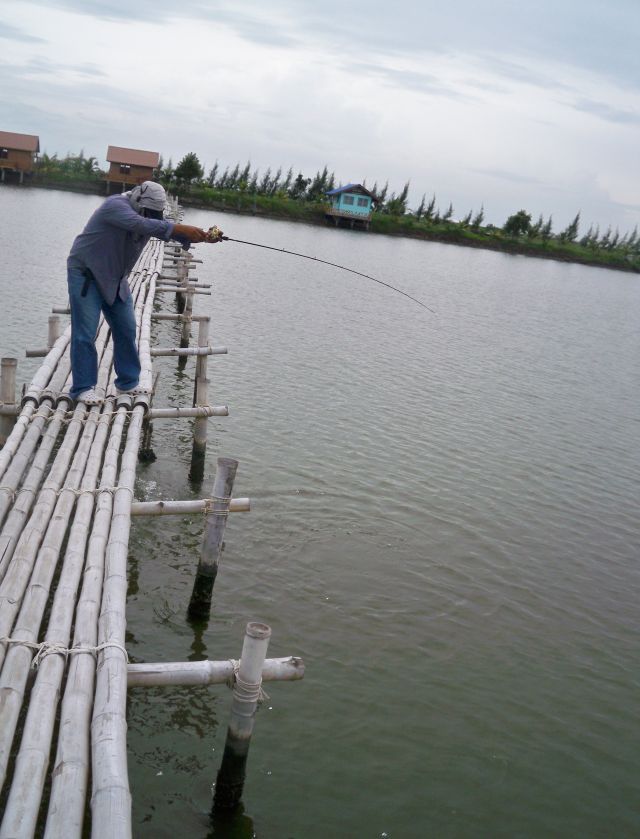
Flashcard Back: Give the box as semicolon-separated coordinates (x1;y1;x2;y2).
127;656;304;688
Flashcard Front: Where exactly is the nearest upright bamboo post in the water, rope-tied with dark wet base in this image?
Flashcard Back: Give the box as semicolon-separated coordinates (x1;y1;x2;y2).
213;623;271;810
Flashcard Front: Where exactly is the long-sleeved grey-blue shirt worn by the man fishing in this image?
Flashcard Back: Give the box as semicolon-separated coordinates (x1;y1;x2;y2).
67;195;188;306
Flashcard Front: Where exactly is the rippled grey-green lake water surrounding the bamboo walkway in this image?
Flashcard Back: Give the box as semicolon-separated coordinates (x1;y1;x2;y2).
0;187;640;839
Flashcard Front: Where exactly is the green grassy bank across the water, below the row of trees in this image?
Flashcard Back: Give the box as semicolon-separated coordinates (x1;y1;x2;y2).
15;178;640;273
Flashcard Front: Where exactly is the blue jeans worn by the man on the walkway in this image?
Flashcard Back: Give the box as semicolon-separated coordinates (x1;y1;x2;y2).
67;268;140;399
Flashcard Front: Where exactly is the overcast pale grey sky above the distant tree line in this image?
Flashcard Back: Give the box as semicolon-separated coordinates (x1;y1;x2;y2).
0;0;640;232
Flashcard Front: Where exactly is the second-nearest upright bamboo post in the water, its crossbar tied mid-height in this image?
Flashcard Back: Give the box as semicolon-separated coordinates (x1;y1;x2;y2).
188;457;238;619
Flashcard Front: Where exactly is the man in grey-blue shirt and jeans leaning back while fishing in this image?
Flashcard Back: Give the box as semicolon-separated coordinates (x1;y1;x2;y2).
67;181;219;405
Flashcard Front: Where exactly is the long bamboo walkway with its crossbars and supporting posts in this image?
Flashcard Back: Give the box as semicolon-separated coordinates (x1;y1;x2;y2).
0;200;304;839
